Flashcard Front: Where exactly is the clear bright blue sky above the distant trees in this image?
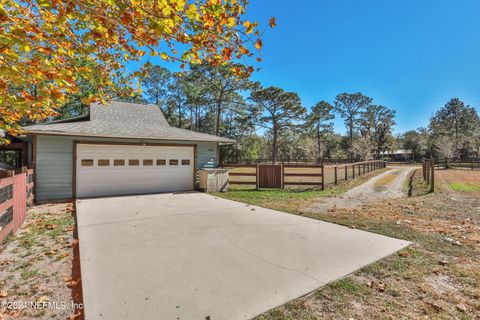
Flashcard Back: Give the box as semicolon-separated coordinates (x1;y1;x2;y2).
244;0;480;133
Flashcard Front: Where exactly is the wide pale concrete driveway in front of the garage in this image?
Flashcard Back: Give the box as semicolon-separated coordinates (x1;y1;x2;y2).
77;193;409;320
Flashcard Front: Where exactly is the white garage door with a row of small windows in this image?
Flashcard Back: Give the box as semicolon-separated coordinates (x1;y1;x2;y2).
76;144;194;198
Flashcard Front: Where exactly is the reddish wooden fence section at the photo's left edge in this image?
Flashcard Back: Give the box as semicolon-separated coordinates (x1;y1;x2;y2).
0;167;34;241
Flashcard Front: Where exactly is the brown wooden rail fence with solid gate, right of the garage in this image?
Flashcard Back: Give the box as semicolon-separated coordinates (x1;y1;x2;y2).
222;160;386;190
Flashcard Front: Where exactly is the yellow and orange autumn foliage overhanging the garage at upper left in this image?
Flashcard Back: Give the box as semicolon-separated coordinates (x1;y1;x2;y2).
0;0;275;141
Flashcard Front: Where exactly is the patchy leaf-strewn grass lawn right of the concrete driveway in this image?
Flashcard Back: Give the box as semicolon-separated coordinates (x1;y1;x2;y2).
219;170;480;320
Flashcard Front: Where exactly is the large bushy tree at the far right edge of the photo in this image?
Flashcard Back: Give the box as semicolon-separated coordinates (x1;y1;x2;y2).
429;98;480;156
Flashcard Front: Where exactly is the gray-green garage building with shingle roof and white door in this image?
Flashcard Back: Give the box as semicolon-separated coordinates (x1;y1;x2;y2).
20;101;235;201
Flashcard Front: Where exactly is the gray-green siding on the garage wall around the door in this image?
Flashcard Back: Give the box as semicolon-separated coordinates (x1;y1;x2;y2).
36;135;218;201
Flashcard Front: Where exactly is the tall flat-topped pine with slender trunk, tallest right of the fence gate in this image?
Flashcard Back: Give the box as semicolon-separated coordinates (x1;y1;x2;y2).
335;92;372;147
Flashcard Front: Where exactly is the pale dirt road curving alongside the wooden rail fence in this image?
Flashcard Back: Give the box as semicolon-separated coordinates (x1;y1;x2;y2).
308;167;414;212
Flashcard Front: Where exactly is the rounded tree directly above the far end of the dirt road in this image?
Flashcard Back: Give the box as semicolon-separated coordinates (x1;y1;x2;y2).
358;105;395;157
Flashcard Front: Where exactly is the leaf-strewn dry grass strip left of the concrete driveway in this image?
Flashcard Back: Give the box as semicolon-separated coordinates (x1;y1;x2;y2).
0;203;79;319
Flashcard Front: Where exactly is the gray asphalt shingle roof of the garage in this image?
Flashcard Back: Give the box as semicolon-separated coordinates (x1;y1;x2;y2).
23;101;235;143
